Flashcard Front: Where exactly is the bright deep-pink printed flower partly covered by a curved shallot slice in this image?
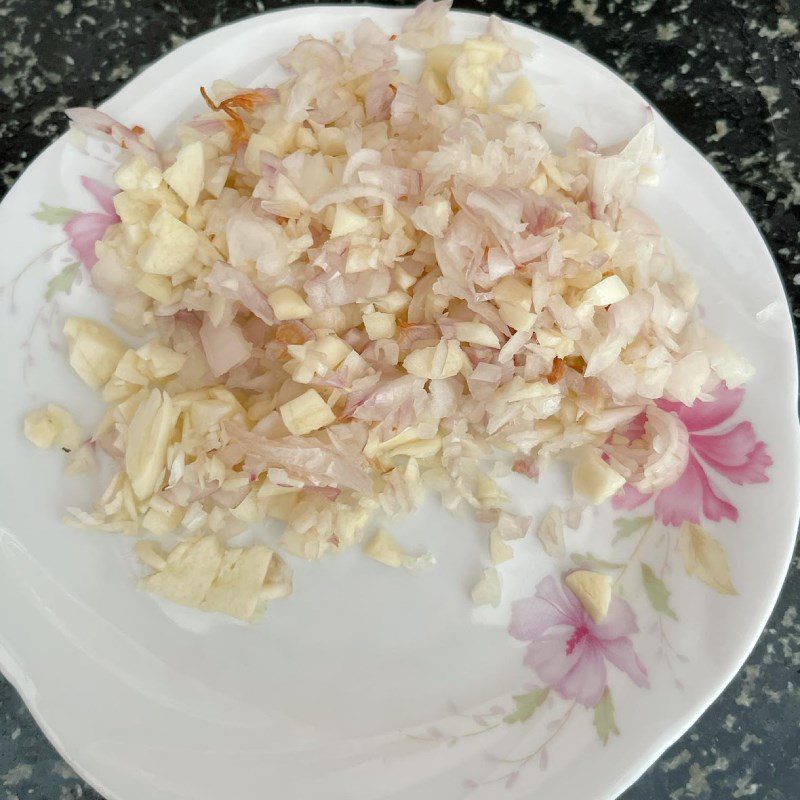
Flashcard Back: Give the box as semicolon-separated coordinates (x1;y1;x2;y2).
613;384;772;526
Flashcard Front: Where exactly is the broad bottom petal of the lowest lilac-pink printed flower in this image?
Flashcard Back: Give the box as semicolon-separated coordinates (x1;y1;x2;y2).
525;628;606;706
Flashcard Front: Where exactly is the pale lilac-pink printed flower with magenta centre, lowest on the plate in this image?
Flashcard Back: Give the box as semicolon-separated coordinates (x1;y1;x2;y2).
508;575;649;708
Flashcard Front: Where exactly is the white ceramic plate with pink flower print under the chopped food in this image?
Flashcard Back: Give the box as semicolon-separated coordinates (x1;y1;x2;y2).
0;6;800;800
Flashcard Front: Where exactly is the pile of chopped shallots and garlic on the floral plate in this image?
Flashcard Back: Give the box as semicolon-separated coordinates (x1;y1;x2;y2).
26;0;750;619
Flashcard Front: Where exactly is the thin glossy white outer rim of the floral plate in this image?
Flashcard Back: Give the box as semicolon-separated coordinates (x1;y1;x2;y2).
0;3;800;800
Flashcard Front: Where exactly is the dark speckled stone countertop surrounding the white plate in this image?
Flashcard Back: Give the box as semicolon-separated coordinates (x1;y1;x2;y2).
0;0;800;800
